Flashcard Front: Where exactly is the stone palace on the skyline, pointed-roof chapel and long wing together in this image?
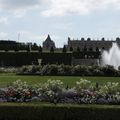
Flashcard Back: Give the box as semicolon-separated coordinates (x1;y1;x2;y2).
43;35;120;51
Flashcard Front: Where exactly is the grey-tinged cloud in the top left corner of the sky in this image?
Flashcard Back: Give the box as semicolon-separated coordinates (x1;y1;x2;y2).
0;0;41;17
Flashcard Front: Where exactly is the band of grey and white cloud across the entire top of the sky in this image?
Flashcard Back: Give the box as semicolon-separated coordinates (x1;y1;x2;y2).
0;0;120;17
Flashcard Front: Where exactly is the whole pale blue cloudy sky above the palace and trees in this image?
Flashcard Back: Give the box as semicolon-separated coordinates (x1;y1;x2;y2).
0;0;120;47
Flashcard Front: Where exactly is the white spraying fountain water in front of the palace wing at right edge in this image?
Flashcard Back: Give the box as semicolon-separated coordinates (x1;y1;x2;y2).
102;43;120;69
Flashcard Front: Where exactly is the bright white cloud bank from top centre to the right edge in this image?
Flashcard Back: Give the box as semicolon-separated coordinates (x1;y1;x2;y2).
42;0;120;16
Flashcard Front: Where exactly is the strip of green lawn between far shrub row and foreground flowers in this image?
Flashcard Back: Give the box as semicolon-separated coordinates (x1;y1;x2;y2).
0;74;120;87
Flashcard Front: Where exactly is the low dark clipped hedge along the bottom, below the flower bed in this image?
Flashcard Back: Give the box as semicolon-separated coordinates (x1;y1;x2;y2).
0;103;120;120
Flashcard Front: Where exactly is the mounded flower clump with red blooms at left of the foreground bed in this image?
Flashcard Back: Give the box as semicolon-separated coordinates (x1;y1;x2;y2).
5;80;32;102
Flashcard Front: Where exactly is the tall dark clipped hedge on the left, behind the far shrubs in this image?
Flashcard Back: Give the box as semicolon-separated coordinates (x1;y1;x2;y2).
0;52;72;67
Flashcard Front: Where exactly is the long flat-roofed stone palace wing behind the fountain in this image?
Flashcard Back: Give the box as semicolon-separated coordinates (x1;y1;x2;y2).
67;38;120;51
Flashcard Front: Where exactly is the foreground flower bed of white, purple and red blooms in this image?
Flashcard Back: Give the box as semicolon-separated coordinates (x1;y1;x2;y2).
0;79;120;104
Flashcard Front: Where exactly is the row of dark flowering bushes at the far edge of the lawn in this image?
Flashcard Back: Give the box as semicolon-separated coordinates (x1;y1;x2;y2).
18;64;120;76
